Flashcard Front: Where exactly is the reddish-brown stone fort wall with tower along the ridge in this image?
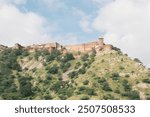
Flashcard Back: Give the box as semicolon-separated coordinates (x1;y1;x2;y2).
0;38;113;53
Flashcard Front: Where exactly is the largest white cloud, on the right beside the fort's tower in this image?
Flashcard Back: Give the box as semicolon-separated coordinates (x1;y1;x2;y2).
92;0;150;66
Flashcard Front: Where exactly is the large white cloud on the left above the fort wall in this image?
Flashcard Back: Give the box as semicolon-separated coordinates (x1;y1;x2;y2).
0;2;54;46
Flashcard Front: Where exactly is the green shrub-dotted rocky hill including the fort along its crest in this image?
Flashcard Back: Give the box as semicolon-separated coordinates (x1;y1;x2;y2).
0;39;150;100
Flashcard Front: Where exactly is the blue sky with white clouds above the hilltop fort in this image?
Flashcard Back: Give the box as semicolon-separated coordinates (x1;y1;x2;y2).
0;0;150;67
